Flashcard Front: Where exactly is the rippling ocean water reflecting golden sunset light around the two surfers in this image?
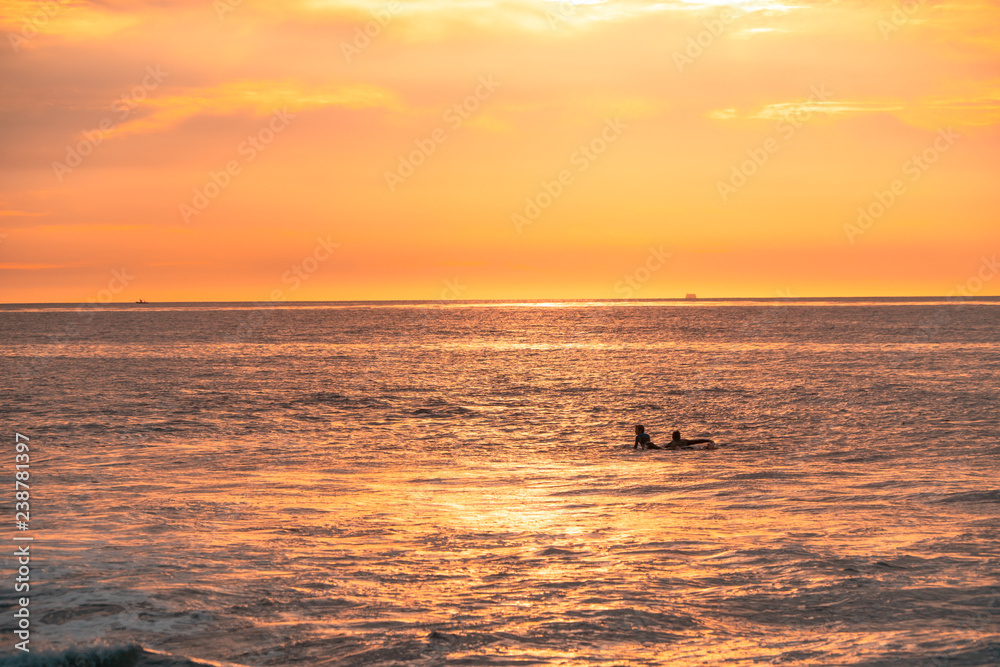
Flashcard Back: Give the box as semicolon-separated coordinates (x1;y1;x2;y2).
0;298;1000;667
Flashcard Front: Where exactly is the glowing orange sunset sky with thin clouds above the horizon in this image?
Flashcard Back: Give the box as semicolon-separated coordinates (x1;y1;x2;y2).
0;0;1000;303
